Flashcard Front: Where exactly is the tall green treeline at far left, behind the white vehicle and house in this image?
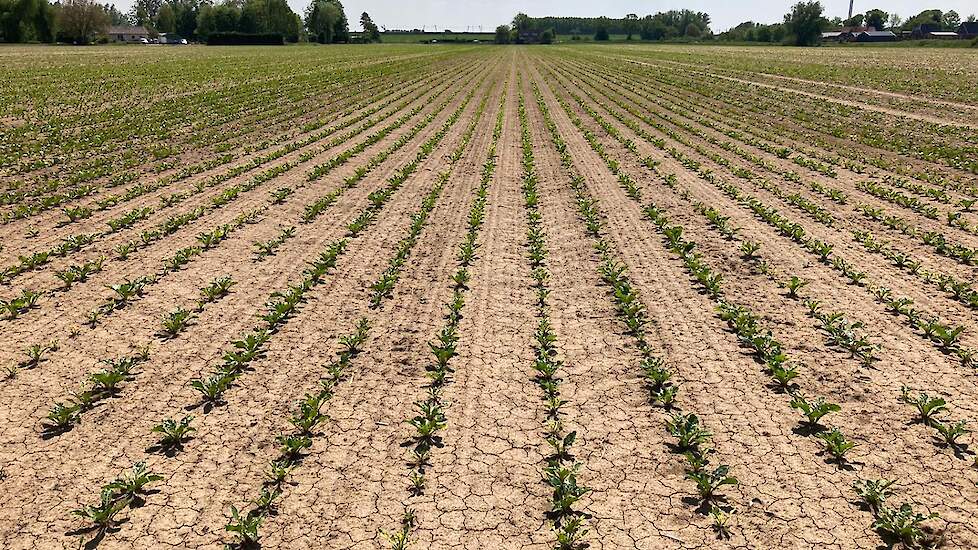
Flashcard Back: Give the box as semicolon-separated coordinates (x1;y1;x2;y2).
0;0;380;43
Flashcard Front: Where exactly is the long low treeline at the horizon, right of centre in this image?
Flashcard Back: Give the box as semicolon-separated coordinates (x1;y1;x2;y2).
512;10;712;40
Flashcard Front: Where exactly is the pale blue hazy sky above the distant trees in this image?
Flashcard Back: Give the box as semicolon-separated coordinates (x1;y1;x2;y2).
314;0;978;31
